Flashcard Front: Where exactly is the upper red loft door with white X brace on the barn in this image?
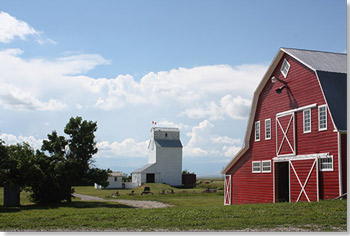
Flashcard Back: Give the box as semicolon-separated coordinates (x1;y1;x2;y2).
276;112;296;156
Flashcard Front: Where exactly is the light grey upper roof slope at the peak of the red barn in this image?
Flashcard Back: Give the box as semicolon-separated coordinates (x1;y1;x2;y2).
281;48;346;73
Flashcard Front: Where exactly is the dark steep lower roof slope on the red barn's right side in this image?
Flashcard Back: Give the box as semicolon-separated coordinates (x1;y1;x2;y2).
317;71;347;131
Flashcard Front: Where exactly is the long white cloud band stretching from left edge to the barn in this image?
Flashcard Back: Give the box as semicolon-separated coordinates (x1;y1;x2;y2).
0;46;266;114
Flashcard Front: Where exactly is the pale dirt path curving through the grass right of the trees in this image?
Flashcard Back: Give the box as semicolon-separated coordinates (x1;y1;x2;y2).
73;193;172;209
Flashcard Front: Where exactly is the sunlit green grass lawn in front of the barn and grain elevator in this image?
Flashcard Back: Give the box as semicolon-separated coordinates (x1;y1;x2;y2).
0;184;347;231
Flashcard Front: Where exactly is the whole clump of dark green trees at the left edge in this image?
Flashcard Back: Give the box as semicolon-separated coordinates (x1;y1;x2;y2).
0;117;111;204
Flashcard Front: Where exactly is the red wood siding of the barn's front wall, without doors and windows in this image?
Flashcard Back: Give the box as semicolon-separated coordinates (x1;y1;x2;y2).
226;54;339;204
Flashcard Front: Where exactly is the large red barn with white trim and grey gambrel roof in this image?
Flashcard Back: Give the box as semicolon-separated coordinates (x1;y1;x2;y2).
221;48;347;205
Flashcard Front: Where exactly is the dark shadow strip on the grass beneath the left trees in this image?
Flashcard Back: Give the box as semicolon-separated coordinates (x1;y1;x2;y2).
0;201;133;213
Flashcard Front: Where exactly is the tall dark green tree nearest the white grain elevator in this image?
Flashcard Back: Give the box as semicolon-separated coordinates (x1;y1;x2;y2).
31;117;106;203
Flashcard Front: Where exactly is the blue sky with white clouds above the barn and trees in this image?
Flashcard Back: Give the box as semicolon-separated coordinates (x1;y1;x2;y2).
0;0;346;176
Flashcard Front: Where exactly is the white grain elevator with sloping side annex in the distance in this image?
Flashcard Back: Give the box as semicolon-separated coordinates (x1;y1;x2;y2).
132;127;182;186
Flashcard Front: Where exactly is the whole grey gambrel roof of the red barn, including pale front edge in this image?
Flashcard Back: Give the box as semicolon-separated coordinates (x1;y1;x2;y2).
221;48;347;174
